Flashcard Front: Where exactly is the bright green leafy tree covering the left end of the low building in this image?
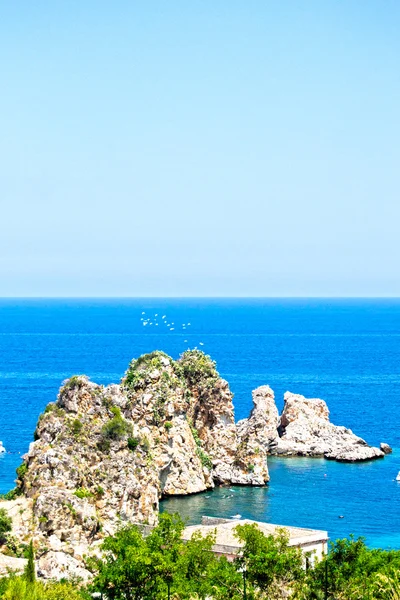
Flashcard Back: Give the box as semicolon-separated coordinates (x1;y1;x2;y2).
89;514;217;600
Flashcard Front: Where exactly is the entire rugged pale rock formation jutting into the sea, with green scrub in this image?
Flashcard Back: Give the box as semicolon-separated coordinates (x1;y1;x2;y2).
0;350;386;579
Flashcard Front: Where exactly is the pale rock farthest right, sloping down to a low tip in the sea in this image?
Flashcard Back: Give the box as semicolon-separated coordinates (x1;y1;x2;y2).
271;392;384;462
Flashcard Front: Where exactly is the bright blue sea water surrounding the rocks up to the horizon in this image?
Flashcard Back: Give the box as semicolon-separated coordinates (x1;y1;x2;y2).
0;299;400;548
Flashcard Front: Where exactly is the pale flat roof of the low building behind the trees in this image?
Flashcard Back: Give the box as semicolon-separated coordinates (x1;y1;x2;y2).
182;519;328;548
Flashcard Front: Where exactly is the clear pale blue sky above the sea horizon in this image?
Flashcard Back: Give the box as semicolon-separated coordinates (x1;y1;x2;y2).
0;0;400;296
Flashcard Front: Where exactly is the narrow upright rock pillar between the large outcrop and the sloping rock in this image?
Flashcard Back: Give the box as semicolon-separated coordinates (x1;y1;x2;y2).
236;385;279;485
